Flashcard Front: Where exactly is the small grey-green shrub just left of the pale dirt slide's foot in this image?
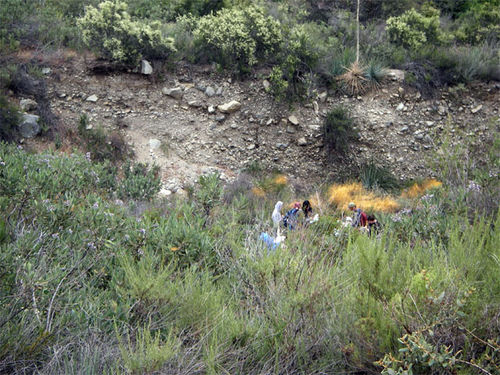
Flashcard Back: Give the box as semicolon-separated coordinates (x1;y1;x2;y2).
118;162;161;200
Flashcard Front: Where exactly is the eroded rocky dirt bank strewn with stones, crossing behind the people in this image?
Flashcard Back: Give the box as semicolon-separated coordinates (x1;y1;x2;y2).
17;58;500;191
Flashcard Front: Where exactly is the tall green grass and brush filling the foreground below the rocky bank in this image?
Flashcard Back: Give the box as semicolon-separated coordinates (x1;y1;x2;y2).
0;144;500;374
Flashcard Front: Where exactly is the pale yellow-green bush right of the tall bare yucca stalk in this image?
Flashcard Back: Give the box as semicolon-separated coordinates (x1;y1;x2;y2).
386;6;446;50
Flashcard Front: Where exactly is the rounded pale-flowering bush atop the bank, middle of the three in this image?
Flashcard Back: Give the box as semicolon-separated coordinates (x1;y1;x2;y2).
193;6;282;72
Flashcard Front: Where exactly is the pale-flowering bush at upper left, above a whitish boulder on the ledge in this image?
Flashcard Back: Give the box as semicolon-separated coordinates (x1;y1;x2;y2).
77;0;174;65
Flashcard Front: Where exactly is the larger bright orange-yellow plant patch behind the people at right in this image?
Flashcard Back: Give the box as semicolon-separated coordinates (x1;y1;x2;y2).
328;182;400;212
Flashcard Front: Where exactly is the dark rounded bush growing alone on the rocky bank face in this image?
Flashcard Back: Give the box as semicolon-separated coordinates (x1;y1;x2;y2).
323;106;359;153
